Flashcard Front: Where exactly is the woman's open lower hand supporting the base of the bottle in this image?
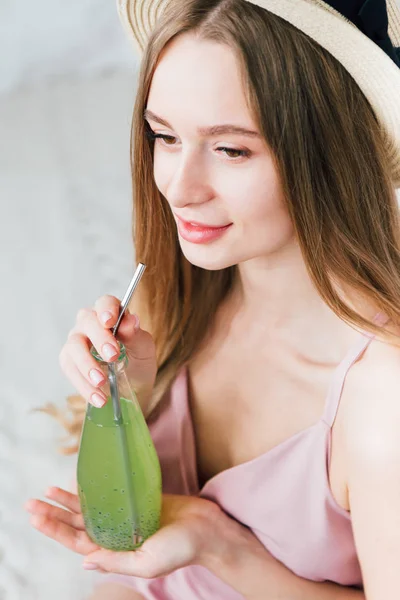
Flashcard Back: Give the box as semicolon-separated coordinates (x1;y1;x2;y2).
26;488;231;578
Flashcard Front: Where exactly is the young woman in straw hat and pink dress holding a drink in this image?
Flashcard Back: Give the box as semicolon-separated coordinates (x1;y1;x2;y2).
27;0;400;600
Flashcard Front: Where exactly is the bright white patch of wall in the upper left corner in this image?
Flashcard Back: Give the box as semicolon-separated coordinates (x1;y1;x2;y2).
0;0;133;93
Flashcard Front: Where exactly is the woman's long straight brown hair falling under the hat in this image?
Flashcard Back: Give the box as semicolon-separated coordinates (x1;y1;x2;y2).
46;0;400;450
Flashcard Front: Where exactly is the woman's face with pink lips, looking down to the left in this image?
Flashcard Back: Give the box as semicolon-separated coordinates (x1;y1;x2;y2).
146;34;293;270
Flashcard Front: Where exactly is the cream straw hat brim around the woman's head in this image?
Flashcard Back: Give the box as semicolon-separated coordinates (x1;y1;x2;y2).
117;0;400;188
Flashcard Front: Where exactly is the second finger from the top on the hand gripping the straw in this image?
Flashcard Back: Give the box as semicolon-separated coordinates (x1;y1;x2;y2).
72;308;120;362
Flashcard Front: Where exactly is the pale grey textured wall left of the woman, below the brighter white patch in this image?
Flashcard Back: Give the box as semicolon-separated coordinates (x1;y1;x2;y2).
0;71;138;600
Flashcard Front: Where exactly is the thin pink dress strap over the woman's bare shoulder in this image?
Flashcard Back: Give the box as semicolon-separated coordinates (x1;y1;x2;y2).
322;312;388;427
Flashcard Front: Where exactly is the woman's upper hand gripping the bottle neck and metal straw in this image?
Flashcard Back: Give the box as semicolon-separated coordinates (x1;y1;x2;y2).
60;295;157;408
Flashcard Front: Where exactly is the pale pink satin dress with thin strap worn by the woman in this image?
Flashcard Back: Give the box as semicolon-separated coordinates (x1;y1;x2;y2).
99;313;387;600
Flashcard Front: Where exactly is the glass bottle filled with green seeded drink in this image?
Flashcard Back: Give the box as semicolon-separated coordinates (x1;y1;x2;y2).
77;342;162;551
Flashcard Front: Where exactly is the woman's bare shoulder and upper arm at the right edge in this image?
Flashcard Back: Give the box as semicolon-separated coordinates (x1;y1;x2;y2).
343;330;400;599
